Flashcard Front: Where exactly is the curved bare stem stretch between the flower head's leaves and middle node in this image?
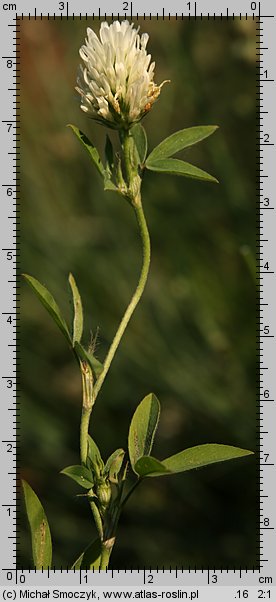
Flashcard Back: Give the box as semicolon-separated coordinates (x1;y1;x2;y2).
93;197;150;403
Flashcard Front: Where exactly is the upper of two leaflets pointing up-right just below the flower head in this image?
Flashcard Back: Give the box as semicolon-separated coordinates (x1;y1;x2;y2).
146;125;218;167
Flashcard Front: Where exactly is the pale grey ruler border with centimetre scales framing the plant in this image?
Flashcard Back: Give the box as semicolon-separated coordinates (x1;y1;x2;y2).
0;0;276;601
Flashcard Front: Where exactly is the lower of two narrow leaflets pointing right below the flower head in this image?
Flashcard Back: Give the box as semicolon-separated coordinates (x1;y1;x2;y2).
146;159;218;182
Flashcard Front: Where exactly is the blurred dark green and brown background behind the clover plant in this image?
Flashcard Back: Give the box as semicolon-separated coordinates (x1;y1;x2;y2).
18;19;258;568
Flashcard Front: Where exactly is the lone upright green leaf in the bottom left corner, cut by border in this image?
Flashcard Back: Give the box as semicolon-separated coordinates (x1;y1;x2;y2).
22;481;52;570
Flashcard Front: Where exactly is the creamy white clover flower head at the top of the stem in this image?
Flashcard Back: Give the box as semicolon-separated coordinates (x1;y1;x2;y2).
76;21;168;128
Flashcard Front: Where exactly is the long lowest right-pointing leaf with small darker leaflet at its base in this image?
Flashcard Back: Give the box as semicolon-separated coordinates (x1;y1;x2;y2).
135;443;253;477
